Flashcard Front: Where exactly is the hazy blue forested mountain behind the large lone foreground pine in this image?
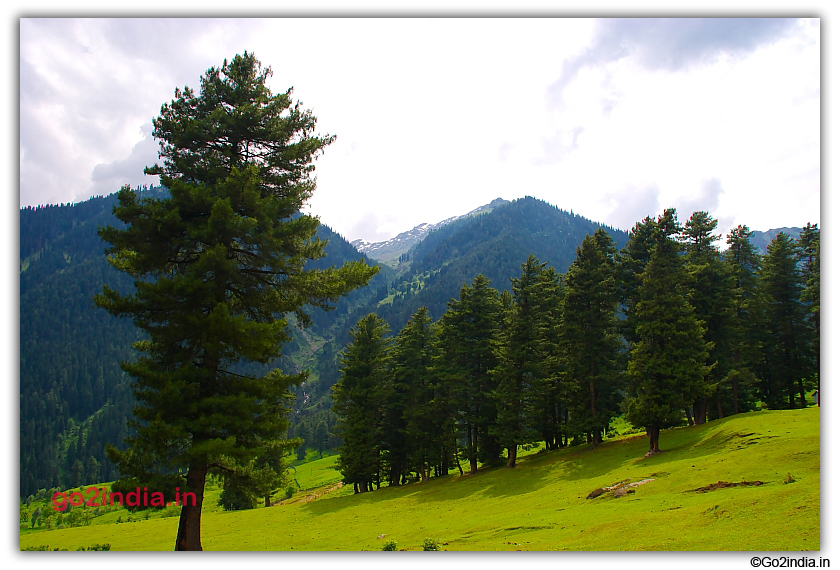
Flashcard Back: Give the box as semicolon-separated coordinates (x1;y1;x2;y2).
20;188;394;497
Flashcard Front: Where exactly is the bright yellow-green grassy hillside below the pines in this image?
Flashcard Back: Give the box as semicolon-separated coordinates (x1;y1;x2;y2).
20;407;820;551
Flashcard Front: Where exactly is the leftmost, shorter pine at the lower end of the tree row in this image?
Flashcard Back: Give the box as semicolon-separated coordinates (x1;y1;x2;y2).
333;313;392;493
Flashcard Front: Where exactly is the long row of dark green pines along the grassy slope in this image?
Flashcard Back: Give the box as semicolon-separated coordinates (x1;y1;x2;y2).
333;208;820;492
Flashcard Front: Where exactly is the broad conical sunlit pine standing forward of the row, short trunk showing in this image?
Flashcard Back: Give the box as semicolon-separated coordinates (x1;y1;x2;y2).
627;208;709;453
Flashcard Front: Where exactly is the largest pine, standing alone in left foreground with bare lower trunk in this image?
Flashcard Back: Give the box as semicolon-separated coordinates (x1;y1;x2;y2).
96;52;376;550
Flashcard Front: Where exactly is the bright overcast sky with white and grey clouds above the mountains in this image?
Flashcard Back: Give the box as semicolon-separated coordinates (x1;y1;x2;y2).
20;18;820;241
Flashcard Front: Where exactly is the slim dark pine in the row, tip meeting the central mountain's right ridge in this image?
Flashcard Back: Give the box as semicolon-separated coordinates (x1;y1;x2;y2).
562;229;622;446
